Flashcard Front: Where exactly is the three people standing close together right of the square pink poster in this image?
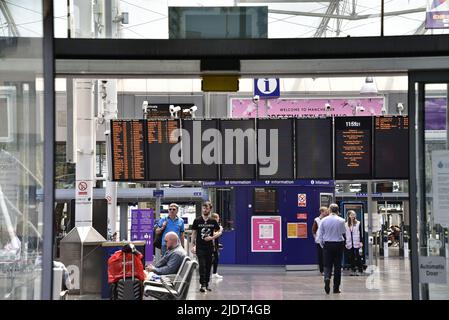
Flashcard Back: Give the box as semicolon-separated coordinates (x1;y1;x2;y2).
312;203;363;294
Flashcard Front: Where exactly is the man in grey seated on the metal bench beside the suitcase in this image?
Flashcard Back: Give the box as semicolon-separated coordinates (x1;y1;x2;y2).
146;232;187;279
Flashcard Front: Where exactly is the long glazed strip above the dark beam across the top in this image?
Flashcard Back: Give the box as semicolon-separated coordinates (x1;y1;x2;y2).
54;0;449;39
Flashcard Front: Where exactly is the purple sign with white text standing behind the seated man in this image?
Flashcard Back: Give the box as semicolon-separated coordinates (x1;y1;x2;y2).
131;209;154;263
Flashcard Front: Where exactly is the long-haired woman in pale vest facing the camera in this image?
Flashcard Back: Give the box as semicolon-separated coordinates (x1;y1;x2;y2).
345;210;363;276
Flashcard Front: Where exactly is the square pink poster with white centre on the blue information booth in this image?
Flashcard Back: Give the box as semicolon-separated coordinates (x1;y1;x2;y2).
251;216;282;252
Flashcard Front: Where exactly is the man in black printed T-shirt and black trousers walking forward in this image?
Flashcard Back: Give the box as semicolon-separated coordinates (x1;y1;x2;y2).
191;201;220;292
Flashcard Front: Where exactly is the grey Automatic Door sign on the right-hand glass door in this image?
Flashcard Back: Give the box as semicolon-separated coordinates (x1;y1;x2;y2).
419;256;447;284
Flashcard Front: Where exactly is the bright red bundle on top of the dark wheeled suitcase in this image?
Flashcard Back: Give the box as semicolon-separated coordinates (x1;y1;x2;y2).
108;250;145;283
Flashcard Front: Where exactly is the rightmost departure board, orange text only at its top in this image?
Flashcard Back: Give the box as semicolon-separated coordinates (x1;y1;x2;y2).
374;117;409;179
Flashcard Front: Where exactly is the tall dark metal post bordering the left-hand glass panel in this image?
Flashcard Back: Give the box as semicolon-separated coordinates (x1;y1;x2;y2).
41;0;55;300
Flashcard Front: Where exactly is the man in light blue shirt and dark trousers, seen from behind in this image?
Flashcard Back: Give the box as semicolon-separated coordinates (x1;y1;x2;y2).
317;203;346;294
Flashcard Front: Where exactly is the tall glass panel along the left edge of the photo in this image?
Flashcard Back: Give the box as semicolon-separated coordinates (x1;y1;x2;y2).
0;0;44;300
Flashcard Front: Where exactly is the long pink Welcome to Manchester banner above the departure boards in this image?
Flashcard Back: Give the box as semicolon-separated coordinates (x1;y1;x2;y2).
231;97;384;118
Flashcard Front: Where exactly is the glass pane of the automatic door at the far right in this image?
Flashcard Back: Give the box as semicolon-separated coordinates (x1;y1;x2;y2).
418;84;449;299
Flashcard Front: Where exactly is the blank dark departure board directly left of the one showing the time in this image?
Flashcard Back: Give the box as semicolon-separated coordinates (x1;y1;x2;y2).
295;118;333;179
